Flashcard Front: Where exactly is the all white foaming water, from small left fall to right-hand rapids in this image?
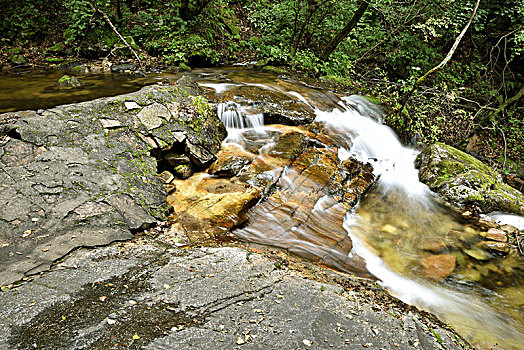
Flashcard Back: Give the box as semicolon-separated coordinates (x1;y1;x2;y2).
213;74;524;348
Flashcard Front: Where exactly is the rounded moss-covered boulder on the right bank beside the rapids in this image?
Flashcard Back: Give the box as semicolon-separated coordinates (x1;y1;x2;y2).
415;143;524;215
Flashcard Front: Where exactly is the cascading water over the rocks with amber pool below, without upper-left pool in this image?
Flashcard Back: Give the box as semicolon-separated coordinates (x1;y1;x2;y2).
198;69;524;349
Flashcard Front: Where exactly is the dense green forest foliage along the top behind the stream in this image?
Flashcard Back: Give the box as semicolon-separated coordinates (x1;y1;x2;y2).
0;0;524;167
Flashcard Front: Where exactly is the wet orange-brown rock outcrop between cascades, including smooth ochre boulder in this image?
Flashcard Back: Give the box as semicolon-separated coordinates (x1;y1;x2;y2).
168;125;374;275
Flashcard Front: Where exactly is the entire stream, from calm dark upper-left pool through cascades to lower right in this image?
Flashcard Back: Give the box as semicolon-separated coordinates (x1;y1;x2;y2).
0;67;524;349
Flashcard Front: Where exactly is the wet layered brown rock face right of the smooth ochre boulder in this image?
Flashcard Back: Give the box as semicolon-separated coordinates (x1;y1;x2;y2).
231;127;374;273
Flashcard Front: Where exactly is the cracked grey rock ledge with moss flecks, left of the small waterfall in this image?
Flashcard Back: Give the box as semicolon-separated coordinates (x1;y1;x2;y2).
0;79;226;286
